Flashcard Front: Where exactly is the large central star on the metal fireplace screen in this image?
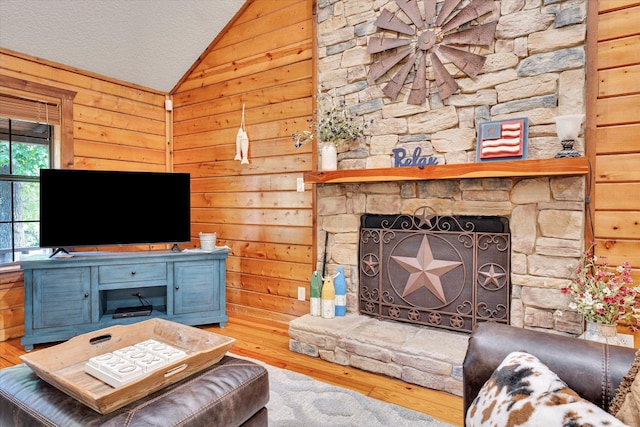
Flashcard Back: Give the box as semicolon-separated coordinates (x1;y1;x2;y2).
391;236;462;304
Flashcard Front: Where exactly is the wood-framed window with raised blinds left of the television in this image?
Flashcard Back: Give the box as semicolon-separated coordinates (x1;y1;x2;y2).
0;74;76;266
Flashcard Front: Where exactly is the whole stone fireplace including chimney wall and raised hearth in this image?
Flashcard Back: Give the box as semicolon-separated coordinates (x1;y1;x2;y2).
290;0;587;395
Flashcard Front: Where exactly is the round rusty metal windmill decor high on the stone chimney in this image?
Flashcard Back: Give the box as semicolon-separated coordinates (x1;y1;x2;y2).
367;0;497;105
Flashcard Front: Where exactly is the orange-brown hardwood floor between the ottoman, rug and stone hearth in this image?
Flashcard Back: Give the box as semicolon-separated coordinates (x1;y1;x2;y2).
0;315;463;426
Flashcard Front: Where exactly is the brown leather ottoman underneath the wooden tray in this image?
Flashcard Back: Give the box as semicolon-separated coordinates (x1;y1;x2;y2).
0;356;269;427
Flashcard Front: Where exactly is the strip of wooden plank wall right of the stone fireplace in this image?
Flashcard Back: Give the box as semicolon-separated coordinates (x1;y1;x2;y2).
590;0;640;283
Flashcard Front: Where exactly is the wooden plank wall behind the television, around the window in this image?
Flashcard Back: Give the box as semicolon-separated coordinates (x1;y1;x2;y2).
0;49;171;341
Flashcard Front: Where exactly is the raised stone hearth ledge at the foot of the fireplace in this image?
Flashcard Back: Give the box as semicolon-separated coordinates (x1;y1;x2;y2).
289;314;469;396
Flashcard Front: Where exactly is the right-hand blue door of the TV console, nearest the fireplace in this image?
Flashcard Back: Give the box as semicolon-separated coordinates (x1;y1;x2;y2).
173;261;222;314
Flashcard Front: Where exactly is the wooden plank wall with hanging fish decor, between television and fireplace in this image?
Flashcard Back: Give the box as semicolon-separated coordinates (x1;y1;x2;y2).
172;0;314;321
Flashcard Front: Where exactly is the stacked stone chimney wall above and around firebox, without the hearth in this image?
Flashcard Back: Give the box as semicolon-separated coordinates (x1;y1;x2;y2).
316;0;586;334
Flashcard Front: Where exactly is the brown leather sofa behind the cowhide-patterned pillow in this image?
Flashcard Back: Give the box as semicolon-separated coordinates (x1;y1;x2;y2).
462;322;636;420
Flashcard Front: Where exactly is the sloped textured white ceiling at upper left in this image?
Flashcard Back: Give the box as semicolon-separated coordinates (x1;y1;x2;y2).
0;0;245;92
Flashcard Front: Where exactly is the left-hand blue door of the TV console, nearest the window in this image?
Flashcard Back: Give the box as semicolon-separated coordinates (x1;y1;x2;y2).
33;267;91;329
